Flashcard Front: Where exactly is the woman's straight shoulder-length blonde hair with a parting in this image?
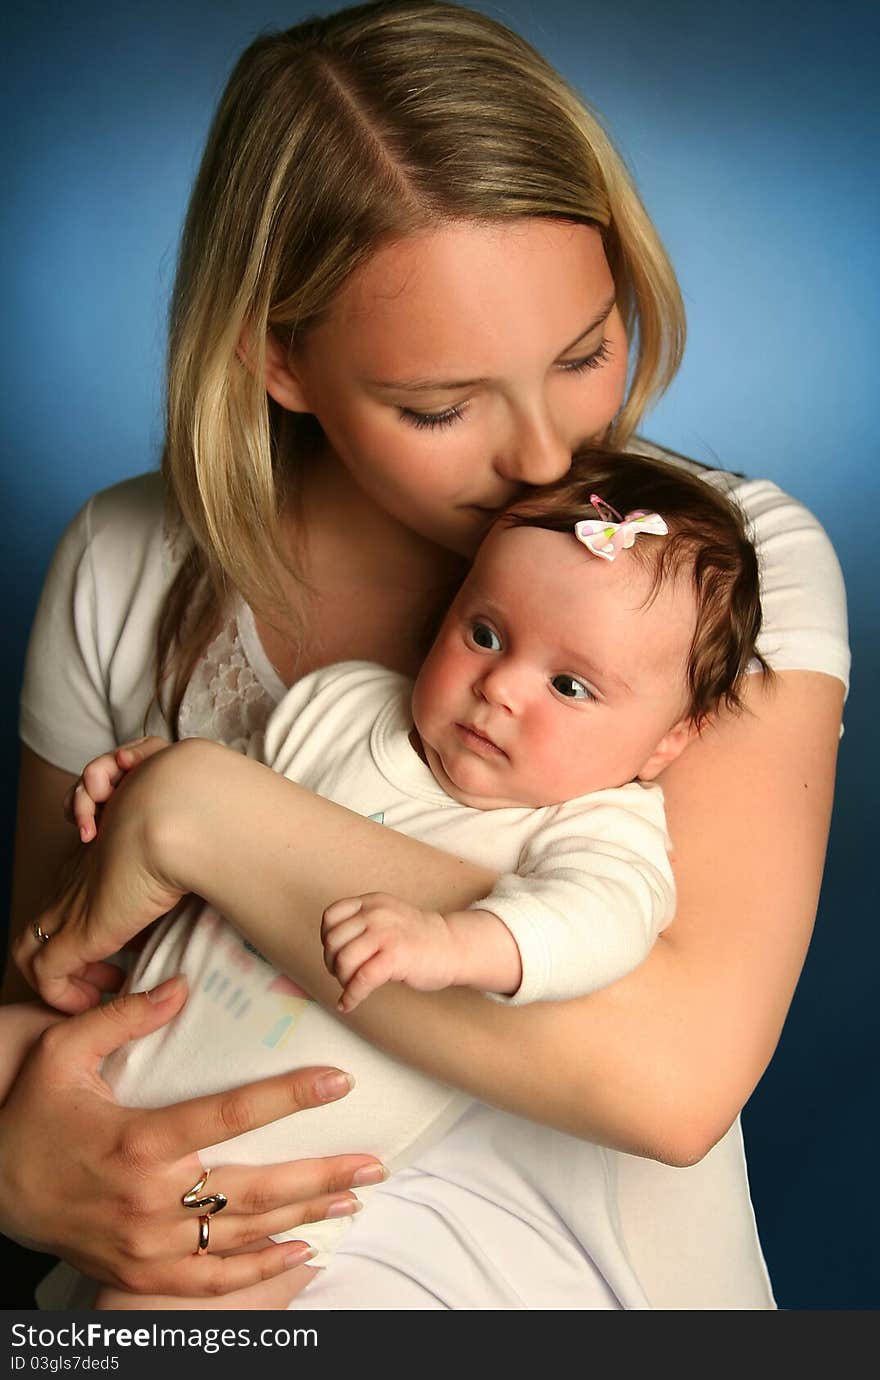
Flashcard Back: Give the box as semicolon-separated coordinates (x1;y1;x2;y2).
159;0;684;707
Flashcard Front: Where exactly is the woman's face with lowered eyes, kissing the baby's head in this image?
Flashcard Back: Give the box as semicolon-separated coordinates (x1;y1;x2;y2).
291;218;626;556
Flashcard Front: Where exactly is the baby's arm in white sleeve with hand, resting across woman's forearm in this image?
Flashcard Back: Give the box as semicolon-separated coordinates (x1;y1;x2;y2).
321;785;674;1012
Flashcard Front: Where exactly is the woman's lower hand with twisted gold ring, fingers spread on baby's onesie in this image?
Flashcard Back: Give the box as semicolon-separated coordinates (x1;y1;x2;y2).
0;980;383;1297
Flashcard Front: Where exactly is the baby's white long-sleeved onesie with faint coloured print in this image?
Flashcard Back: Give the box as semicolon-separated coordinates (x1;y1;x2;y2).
103;661;674;1264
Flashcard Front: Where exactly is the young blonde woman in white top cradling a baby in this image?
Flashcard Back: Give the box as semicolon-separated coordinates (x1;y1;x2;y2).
1;4;846;1308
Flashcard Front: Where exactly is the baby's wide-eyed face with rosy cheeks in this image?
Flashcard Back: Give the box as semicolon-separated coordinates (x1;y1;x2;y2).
412;526;697;810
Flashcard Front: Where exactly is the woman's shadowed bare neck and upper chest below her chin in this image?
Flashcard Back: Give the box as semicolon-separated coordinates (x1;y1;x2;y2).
258;454;466;683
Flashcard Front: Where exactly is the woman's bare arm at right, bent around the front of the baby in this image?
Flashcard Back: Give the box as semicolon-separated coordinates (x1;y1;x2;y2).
29;672;843;1165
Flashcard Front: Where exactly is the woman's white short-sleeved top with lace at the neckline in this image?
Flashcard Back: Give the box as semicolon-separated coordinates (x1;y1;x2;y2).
21;446;850;1310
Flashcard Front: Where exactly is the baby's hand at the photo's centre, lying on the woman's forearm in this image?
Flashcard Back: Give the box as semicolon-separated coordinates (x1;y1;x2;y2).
321;893;458;1012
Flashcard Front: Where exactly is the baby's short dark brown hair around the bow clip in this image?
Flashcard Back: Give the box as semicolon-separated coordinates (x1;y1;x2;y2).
502;447;772;729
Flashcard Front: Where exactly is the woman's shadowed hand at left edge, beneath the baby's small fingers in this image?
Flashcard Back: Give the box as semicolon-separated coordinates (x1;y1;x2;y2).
12;747;189;1014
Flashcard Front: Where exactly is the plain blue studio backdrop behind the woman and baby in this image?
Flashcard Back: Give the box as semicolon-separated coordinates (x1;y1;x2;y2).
0;0;880;1308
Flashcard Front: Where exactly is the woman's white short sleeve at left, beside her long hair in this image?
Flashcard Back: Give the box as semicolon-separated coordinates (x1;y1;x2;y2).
19;475;177;773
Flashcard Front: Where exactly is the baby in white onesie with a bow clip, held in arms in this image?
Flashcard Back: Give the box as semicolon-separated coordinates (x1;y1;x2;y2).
8;451;763;1307
